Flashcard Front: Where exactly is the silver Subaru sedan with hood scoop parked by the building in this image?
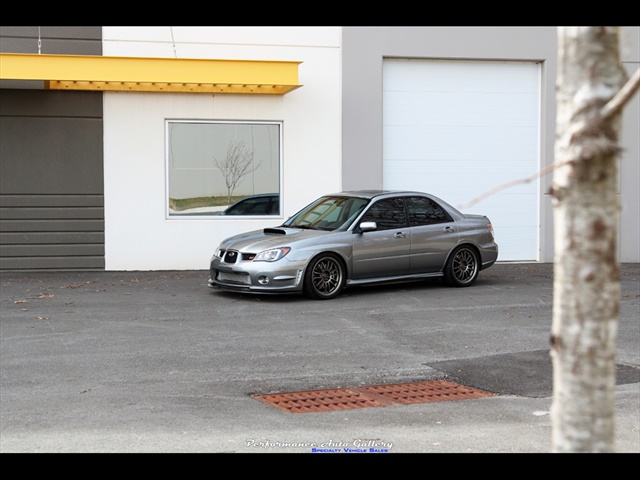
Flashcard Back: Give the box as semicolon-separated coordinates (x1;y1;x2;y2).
209;190;498;300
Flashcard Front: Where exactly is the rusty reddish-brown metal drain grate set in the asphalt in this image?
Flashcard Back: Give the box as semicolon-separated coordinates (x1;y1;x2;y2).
252;380;495;413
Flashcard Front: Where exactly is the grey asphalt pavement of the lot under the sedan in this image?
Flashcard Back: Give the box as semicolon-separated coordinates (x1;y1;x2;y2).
0;263;640;454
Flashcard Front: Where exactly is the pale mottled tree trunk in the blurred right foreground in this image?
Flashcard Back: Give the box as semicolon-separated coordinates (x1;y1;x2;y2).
551;27;627;452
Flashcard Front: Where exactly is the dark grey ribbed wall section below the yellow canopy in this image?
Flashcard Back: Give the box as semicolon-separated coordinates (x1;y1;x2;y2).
0;89;105;271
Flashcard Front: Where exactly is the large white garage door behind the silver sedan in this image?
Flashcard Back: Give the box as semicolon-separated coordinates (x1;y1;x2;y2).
383;59;540;261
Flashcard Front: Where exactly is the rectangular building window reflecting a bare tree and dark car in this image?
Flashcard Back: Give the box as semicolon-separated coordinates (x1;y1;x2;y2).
166;120;282;218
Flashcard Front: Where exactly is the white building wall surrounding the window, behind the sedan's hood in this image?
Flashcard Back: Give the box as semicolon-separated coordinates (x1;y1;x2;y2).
103;27;341;270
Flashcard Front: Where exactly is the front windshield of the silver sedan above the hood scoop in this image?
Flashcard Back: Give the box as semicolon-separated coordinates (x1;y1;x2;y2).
283;197;369;230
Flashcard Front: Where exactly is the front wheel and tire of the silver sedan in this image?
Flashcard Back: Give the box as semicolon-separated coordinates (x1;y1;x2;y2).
302;253;345;300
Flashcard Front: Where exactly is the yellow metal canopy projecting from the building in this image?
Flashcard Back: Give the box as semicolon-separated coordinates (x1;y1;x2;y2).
0;53;302;95
